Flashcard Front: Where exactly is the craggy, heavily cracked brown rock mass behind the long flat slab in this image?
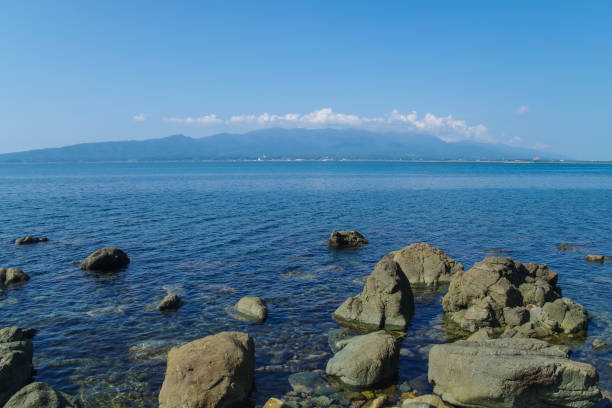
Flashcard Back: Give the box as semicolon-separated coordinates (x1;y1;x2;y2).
442;257;588;337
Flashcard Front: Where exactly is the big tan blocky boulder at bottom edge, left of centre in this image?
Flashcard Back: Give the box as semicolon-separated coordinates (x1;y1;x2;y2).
159;332;255;408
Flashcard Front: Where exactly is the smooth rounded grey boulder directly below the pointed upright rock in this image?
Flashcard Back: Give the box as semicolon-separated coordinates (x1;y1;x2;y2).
325;331;400;388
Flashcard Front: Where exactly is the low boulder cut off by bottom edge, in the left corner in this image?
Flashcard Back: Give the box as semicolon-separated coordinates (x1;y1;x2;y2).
4;382;81;408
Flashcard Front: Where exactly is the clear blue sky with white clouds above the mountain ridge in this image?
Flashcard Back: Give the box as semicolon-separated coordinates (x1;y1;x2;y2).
0;1;612;160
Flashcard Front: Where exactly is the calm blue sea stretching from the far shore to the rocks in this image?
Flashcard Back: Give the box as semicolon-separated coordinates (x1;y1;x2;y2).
0;162;612;406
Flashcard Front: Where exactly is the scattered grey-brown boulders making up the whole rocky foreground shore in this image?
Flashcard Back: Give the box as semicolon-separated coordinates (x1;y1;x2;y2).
0;231;610;408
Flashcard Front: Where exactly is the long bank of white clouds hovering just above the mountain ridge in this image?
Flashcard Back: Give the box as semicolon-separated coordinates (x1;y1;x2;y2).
164;108;493;142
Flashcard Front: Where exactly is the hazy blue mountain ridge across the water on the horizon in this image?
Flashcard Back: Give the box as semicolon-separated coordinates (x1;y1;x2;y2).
0;129;564;163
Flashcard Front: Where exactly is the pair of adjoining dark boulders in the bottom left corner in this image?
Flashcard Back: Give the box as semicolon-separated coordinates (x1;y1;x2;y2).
0;327;81;408
